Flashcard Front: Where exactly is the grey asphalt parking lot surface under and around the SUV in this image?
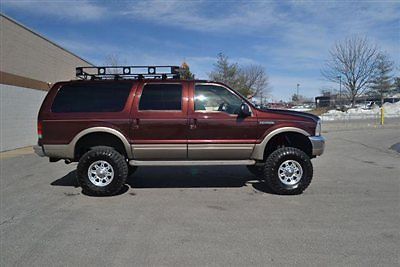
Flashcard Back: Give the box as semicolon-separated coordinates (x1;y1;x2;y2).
0;127;400;266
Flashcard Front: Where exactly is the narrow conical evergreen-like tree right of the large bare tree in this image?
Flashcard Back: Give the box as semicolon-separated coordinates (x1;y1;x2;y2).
369;53;394;105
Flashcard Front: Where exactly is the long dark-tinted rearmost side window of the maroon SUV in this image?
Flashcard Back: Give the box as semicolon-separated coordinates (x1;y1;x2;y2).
51;82;132;113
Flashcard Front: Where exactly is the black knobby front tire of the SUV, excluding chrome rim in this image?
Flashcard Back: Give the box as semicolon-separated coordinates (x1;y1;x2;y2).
263;147;313;195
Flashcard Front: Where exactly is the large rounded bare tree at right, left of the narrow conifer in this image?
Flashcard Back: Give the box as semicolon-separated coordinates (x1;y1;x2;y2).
321;37;379;107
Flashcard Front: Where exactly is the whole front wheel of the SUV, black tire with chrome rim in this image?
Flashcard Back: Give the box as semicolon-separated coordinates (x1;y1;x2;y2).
263;147;313;195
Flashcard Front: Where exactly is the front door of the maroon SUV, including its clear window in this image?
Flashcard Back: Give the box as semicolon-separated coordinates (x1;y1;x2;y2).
188;83;258;160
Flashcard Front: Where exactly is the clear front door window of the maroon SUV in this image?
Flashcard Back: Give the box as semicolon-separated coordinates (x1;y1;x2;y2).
194;84;242;114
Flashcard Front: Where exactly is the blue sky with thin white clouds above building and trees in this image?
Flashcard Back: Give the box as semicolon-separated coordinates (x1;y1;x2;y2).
1;0;400;100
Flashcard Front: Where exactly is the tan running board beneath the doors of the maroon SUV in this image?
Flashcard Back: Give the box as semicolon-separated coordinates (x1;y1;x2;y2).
129;159;256;166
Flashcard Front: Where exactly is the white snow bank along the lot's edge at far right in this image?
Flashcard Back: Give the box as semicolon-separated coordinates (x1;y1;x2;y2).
321;102;400;121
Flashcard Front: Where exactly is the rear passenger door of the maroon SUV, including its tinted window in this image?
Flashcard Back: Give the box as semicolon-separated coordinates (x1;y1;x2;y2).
130;81;188;160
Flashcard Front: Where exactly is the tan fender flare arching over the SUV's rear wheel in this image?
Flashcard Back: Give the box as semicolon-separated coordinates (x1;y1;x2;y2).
68;127;132;158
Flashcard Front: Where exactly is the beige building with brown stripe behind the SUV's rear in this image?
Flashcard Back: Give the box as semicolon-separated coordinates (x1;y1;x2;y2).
0;14;92;151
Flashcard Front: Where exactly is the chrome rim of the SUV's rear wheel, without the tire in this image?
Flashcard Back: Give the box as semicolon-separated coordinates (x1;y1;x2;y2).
88;160;114;186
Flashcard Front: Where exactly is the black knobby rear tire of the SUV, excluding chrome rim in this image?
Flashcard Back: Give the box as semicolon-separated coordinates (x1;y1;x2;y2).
77;146;128;196
